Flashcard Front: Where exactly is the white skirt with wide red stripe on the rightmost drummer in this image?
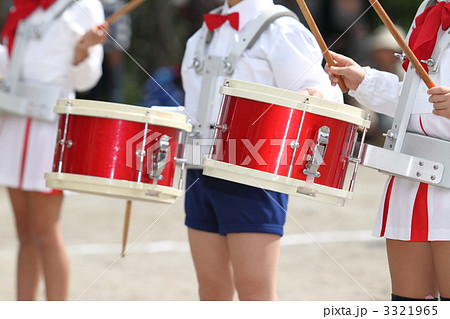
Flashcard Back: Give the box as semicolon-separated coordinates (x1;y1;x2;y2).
373;177;450;241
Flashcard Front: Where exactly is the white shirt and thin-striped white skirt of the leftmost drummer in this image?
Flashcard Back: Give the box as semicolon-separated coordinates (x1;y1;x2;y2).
0;0;104;192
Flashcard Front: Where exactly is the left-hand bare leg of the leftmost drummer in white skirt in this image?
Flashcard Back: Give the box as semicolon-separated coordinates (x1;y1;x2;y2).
8;189;41;300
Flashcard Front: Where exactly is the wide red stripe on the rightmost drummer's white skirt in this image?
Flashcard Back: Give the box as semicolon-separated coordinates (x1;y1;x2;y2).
411;183;428;241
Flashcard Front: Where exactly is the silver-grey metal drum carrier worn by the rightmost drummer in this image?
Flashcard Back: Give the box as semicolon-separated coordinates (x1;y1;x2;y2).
361;1;450;189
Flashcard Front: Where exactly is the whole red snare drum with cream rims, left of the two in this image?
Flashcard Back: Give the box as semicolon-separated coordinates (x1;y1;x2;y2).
45;100;191;203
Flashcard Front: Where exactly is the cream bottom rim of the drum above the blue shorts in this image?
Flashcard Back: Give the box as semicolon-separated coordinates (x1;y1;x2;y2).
203;159;353;206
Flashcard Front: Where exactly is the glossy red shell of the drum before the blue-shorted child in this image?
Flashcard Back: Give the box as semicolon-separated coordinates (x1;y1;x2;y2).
210;95;357;189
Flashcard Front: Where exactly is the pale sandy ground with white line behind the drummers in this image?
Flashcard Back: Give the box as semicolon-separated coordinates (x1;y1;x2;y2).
0;167;390;301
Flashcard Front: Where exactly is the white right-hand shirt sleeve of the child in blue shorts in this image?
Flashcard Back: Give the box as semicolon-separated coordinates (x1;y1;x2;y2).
268;17;343;103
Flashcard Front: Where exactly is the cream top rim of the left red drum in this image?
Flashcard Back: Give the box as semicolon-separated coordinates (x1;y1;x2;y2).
54;99;192;132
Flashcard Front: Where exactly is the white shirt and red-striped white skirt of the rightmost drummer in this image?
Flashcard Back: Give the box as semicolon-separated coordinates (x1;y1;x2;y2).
350;1;450;241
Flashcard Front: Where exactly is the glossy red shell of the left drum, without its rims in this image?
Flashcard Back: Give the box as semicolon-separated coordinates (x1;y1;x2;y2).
53;114;180;187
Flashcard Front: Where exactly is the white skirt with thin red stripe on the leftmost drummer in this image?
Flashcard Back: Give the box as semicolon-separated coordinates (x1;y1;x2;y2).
0;114;58;192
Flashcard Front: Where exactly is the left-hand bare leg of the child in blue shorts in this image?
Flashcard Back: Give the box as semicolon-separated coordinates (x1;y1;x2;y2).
188;228;235;300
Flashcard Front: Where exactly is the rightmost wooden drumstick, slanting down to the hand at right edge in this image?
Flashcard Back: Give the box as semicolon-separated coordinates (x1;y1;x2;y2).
369;0;436;89
